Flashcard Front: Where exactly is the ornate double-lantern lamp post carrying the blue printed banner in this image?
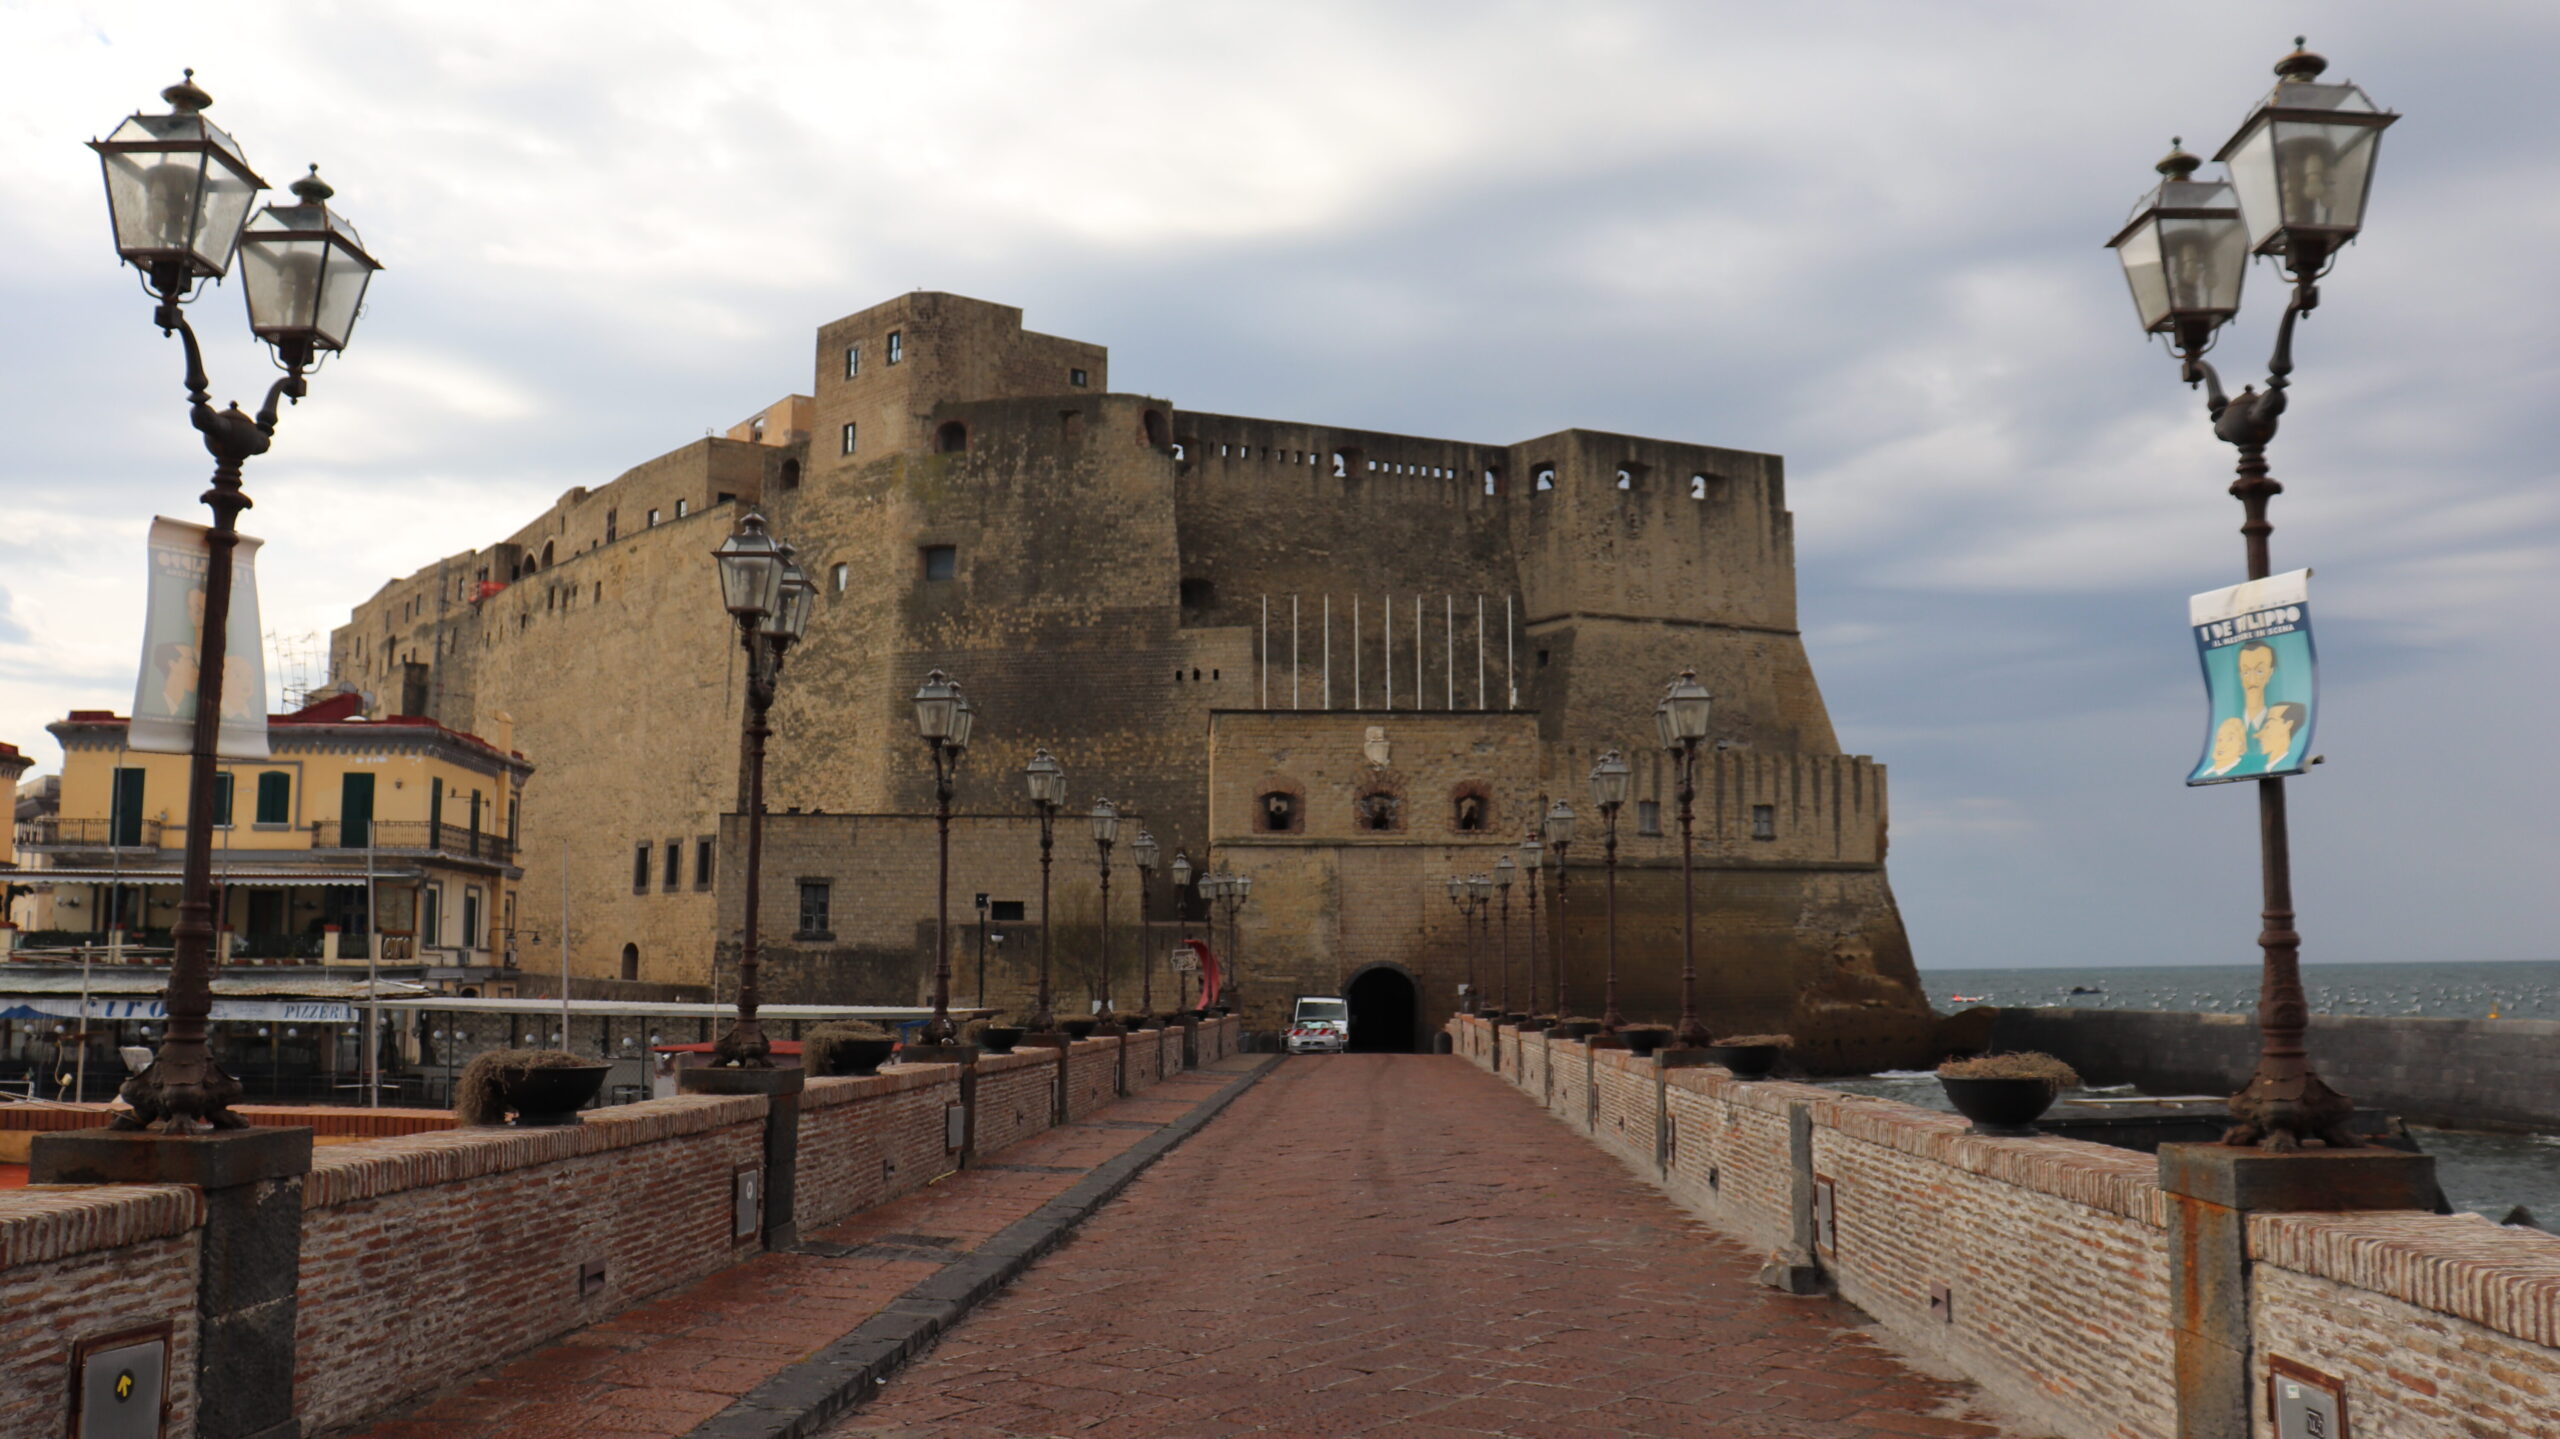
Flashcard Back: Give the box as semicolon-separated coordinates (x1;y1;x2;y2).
2107;38;2399;1150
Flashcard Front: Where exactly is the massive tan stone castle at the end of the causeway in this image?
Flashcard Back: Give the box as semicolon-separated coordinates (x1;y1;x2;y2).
330;292;1930;1065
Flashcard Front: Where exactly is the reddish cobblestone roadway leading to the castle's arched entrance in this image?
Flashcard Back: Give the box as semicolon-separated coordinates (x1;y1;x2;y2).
832;1055;2002;1439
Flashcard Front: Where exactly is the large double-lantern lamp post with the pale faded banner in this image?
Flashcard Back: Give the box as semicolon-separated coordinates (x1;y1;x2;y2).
90;69;381;1134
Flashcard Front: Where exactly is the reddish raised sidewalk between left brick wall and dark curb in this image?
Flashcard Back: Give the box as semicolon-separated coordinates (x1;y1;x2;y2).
358;1057;1260;1439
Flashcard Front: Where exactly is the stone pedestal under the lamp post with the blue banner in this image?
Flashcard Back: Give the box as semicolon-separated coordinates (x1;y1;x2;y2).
2161;1145;2437;1439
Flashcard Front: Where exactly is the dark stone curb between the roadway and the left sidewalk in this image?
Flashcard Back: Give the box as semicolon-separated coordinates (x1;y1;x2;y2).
684;1055;1280;1439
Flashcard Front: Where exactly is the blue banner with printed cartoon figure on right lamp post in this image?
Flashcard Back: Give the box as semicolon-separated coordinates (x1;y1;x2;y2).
2186;568;2319;784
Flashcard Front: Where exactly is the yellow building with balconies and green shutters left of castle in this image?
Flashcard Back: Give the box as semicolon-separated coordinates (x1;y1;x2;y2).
13;694;532;978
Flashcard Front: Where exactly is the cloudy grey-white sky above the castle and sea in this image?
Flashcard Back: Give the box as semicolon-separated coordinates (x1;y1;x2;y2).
0;0;2560;968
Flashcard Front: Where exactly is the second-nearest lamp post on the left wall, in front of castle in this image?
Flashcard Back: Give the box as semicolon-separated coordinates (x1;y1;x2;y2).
712;510;817;1070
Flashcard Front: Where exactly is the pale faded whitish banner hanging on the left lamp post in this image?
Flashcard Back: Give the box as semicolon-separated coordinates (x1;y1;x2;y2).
128;517;266;760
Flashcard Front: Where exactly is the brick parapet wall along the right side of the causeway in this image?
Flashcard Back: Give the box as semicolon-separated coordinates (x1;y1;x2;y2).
1449;1019;2560;1439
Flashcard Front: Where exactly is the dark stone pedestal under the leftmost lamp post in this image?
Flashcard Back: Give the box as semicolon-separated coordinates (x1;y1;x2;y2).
26;1129;312;1439
